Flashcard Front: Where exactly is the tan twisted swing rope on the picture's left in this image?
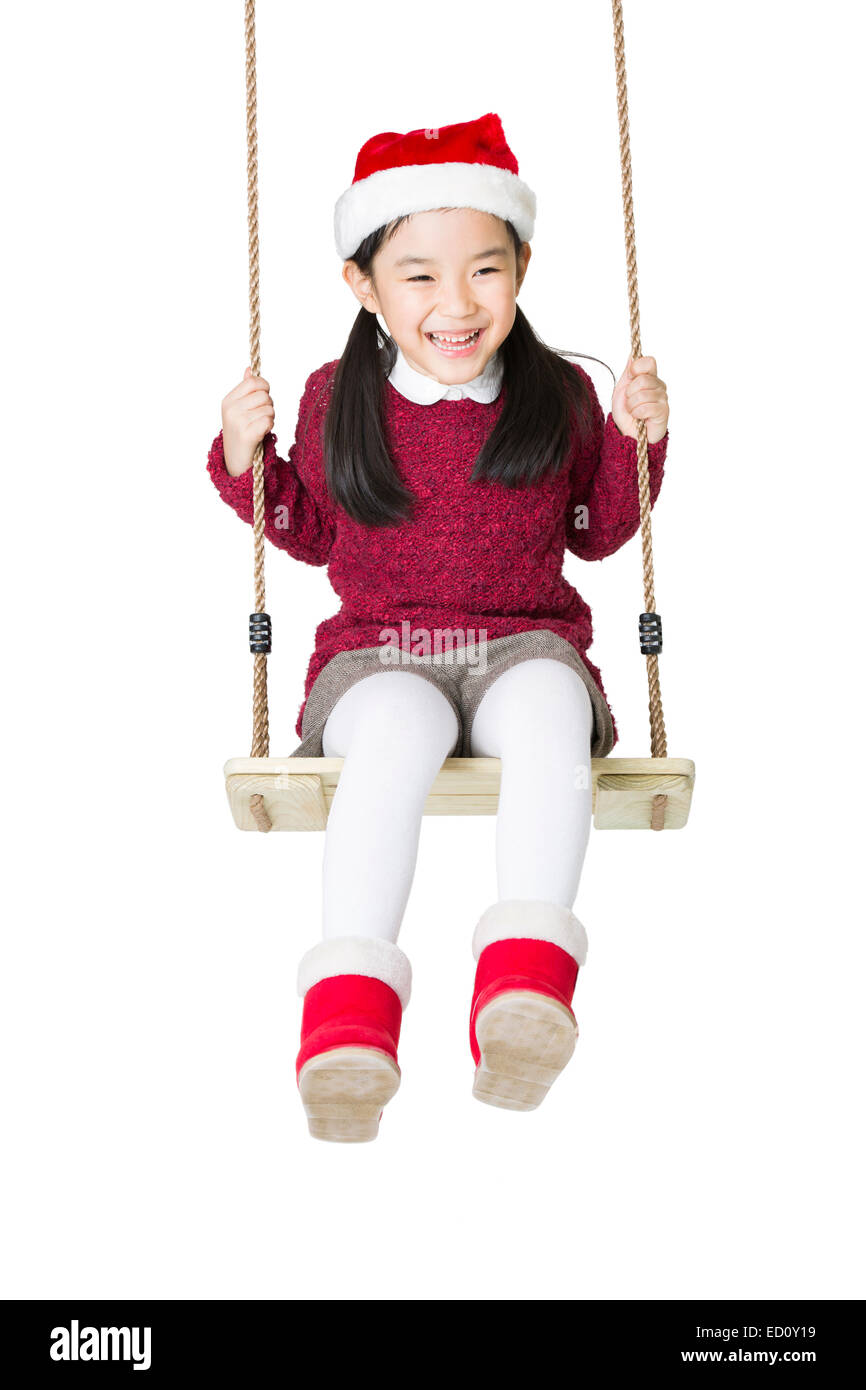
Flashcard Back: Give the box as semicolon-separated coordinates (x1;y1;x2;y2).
243;0;271;830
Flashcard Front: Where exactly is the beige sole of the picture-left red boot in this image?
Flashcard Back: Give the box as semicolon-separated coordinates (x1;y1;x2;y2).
297;1047;400;1144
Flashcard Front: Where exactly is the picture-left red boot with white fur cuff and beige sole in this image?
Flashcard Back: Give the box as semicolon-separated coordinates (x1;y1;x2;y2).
296;937;411;1143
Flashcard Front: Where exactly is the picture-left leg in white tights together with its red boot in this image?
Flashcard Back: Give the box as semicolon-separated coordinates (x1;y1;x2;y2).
296;670;459;1143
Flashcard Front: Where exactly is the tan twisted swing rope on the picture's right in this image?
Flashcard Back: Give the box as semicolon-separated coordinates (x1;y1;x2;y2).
612;0;667;772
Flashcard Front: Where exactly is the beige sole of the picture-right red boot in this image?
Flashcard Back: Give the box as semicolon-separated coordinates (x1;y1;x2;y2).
473;990;577;1111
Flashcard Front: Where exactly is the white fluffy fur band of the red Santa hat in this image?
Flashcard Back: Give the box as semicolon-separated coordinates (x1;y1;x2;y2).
334;160;535;260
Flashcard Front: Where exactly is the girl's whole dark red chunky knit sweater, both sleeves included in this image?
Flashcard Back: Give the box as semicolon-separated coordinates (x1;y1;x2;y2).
207;361;669;744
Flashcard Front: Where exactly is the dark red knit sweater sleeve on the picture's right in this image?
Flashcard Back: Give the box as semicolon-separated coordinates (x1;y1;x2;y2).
566;373;669;560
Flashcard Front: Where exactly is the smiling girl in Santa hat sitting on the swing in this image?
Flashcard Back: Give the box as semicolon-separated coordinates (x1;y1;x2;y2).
207;113;669;1140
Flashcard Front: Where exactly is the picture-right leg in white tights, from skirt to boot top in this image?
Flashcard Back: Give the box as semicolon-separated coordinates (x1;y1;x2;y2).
471;657;592;908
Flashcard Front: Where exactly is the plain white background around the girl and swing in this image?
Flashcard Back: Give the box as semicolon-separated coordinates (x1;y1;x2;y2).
0;0;866;1300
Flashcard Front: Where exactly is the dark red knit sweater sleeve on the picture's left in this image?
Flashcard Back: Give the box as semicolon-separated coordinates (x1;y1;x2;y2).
207;373;335;564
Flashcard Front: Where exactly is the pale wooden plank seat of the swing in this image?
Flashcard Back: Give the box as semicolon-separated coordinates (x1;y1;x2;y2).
224;758;695;830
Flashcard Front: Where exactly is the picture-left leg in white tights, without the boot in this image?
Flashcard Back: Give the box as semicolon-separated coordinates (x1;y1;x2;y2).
322;671;459;941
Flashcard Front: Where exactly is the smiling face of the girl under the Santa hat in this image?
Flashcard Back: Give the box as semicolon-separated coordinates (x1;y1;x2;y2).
343;207;531;385
